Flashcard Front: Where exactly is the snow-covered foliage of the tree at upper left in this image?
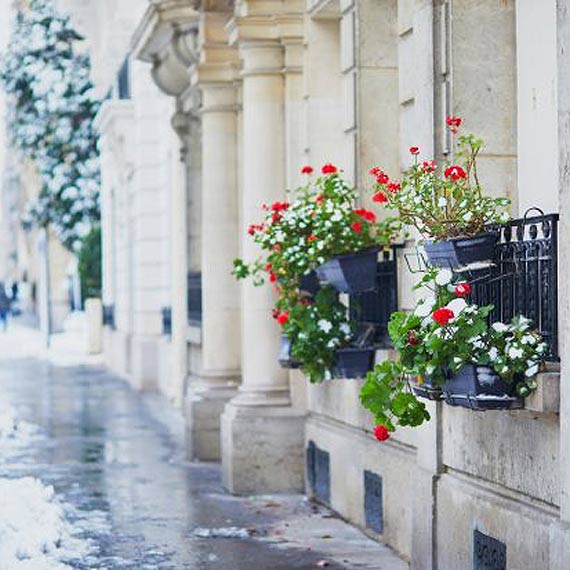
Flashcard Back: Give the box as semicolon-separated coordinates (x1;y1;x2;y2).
0;0;100;249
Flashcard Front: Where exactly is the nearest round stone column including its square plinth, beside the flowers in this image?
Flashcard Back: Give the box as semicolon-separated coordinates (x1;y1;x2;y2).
222;31;304;493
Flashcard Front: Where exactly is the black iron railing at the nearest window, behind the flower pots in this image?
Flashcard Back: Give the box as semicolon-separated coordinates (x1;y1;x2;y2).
473;208;559;360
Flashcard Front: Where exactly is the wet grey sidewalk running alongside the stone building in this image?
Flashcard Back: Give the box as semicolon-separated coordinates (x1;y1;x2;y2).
0;322;407;570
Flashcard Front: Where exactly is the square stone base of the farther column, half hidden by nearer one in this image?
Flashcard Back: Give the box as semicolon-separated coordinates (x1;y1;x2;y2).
184;376;238;461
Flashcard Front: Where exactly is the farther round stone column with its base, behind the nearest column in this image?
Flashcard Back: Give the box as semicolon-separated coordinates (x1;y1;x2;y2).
185;13;241;460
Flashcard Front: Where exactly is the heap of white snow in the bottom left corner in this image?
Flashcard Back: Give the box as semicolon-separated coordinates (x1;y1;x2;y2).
0;477;76;570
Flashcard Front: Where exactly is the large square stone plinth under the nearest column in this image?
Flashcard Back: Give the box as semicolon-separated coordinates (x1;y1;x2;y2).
221;398;305;495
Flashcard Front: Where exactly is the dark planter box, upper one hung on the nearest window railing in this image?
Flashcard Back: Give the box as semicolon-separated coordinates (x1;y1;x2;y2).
423;232;499;268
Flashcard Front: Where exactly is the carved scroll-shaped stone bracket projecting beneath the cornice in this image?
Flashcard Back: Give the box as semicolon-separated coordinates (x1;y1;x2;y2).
132;0;199;96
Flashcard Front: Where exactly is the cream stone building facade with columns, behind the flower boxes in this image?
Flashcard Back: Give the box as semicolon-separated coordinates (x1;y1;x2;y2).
64;0;570;570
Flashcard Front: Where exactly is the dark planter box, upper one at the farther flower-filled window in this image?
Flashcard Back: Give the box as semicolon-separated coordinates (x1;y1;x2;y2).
316;247;378;293
